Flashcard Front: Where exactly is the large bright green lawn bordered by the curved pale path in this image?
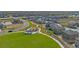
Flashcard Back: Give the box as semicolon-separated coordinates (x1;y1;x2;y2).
0;32;60;48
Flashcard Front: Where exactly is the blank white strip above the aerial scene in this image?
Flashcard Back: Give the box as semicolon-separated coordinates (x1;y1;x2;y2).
0;0;79;11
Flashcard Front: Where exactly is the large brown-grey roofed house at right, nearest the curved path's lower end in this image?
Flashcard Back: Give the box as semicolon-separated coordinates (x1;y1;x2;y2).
62;30;79;44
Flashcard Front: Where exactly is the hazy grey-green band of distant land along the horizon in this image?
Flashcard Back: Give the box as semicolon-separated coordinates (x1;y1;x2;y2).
0;11;79;17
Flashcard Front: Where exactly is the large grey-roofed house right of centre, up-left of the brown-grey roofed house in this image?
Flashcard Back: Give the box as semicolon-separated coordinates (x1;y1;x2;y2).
46;22;65;35
